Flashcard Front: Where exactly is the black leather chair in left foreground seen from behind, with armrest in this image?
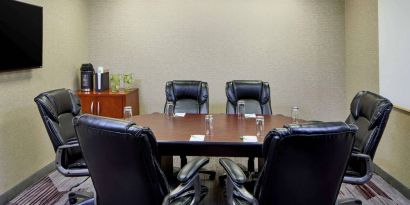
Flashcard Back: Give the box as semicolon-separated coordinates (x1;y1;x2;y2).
74;114;209;205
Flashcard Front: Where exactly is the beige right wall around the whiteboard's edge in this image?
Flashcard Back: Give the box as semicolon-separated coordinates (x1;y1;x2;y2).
345;0;410;187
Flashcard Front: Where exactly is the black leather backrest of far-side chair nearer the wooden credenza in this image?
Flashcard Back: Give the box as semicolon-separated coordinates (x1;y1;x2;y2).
164;80;209;114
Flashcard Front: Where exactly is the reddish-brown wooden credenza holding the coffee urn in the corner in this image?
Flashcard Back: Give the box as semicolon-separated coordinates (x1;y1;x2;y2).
77;88;139;118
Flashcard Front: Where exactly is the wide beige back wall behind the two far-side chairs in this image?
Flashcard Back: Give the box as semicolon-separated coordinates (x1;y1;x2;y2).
89;0;346;120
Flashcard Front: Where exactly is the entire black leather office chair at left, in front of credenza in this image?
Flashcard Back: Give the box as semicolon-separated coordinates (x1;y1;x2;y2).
34;89;90;203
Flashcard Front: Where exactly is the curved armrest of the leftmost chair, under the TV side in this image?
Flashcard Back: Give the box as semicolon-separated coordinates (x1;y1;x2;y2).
55;142;89;176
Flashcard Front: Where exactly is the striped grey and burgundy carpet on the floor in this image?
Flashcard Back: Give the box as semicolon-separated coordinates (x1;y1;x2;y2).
8;171;410;205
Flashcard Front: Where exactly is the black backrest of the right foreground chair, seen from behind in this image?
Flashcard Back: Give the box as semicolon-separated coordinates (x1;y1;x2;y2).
254;122;357;205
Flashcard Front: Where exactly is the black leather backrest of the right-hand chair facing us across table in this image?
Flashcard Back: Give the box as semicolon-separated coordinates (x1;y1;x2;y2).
225;80;272;115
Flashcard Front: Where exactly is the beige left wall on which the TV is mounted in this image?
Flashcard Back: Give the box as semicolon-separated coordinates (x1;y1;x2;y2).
0;0;88;194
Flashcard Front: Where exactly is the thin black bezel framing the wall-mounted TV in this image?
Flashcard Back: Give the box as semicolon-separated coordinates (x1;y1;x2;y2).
0;0;44;73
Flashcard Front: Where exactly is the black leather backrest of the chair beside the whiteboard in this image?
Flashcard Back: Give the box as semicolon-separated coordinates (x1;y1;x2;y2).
346;91;393;159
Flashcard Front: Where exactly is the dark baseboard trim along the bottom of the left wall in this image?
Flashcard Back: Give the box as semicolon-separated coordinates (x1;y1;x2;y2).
0;162;56;205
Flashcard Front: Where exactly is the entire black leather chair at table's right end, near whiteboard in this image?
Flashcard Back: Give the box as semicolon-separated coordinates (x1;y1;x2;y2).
344;91;393;184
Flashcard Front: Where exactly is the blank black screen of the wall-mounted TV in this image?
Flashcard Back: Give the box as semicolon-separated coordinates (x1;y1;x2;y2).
0;0;43;71
